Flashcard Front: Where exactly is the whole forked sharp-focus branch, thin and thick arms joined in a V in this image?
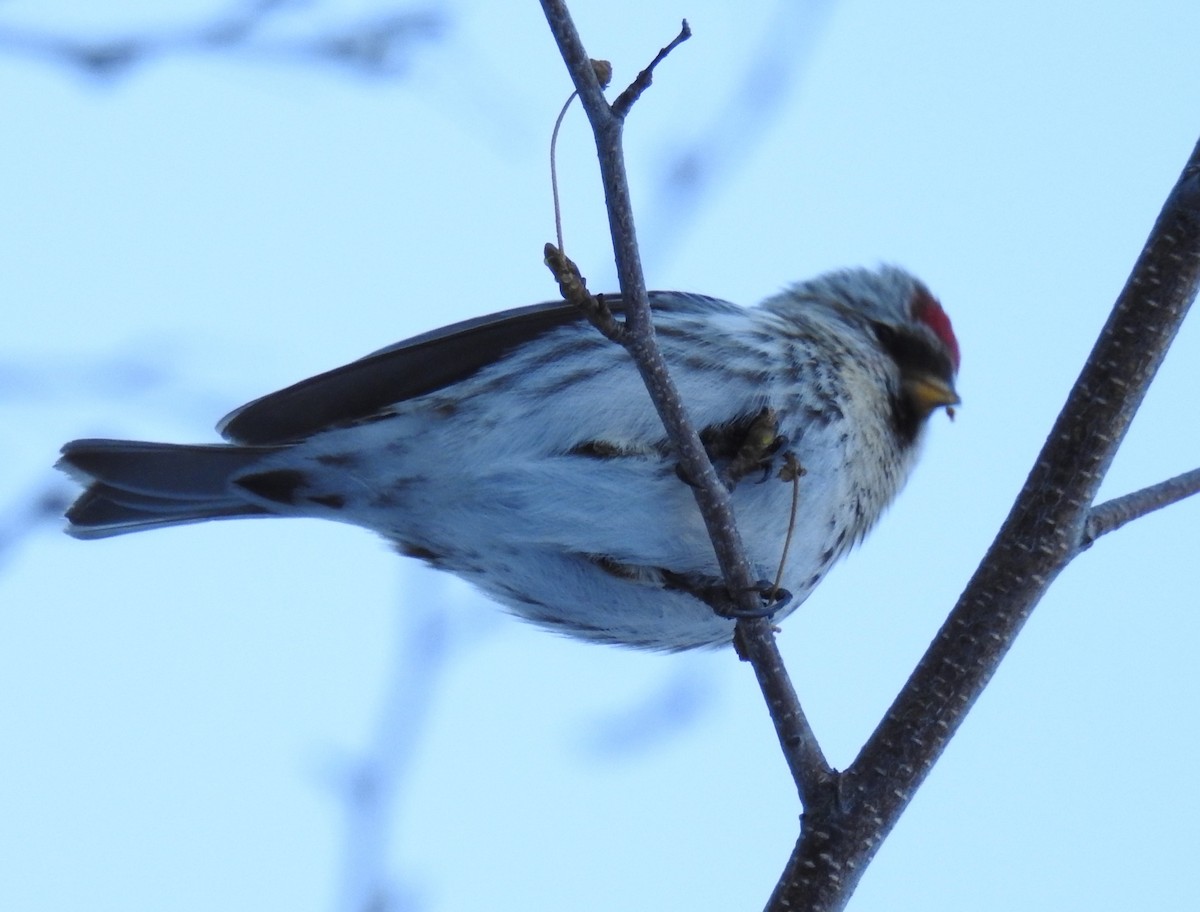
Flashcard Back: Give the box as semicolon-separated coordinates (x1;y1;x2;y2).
542;0;1200;910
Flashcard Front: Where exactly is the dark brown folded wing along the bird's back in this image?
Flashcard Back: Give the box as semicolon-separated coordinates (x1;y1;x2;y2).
217;292;738;446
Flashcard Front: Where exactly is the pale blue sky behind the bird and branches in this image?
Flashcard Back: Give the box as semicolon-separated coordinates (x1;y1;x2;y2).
0;0;1200;912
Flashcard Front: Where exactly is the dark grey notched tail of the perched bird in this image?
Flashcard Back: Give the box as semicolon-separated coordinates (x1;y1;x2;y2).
58;440;281;539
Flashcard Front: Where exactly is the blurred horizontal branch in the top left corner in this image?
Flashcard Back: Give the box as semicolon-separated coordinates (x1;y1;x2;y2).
0;0;449;79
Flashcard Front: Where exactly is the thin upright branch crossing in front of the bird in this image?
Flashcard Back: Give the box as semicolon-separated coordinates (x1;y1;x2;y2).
541;0;833;805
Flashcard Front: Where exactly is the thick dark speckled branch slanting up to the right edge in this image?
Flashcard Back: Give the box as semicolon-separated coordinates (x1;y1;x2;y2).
768;135;1200;910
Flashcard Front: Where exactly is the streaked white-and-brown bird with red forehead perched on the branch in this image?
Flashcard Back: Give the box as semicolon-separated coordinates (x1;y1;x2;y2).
59;266;959;650
